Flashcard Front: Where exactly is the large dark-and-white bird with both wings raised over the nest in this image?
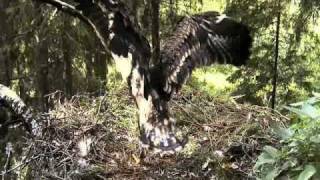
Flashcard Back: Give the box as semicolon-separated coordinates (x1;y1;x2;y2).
0;0;252;152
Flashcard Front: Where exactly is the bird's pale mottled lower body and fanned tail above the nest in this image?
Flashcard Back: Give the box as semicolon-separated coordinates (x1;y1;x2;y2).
129;66;187;153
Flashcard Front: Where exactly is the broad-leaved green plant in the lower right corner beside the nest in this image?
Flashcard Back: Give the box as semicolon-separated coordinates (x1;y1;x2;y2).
254;94;320;180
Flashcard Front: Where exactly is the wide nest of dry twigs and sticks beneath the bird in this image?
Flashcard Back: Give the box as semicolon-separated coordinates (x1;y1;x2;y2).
2;83;287;179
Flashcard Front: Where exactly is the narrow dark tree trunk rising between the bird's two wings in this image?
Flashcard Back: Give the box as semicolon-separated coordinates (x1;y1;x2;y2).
151;0;160;64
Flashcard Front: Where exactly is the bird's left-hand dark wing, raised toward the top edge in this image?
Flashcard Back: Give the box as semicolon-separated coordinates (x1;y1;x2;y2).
74;0;151;68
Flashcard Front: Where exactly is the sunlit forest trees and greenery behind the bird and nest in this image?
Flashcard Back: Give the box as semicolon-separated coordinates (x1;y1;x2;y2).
0;0;320;110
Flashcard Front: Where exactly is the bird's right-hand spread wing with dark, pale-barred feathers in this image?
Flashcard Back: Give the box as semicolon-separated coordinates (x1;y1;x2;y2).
152;12;252;99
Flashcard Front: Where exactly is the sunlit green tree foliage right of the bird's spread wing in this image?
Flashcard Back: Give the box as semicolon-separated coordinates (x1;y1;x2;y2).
226;0;320;105
